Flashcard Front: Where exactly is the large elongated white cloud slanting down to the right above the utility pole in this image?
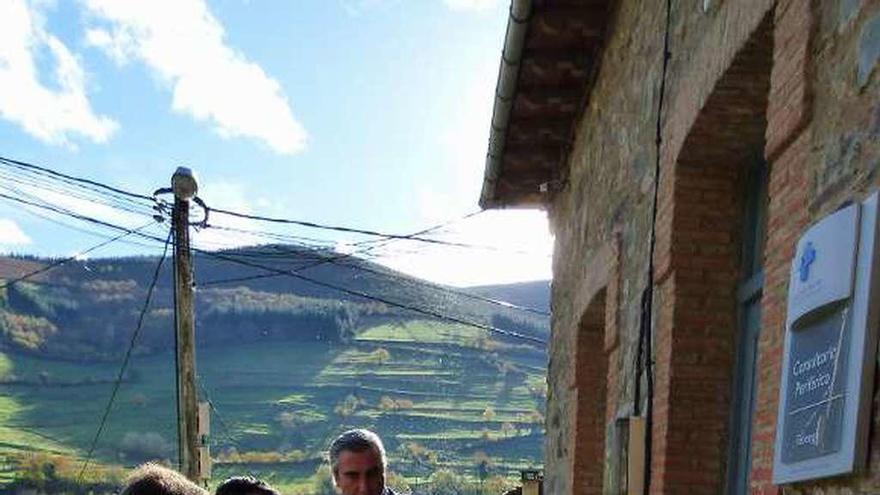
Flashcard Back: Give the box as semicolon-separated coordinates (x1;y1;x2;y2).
85;0;307;154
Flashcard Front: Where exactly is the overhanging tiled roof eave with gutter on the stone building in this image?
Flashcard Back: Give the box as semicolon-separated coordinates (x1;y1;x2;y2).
480;0;613;208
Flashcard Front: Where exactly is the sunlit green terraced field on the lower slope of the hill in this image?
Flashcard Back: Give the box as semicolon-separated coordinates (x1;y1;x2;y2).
0;320;546;492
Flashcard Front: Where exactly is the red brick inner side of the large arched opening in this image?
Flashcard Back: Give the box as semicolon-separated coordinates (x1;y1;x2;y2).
651;10;773;495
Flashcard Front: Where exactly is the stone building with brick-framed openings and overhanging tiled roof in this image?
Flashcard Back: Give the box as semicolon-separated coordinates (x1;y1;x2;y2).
481;0;880;494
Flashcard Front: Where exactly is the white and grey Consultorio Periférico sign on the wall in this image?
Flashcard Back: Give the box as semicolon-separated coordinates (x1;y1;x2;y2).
773;193;880;484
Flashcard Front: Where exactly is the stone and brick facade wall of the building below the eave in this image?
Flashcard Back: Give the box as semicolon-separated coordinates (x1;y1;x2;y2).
545;0;880;494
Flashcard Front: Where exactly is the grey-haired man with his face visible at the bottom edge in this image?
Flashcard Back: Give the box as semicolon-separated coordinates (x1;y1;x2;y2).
330;430;395;495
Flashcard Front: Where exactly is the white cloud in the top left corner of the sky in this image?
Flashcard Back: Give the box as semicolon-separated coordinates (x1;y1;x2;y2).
0;0;118;146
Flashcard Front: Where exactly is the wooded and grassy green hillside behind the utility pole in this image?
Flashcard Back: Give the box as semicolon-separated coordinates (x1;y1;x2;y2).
0;248;547;493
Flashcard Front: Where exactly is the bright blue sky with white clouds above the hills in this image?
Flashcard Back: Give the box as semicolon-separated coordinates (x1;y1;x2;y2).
0;0;552;286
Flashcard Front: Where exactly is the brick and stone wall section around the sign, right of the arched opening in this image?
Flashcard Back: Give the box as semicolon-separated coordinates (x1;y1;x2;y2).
751;0;880;495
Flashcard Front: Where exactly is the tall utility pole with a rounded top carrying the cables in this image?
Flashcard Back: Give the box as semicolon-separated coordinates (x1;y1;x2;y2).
171;167;202;483
